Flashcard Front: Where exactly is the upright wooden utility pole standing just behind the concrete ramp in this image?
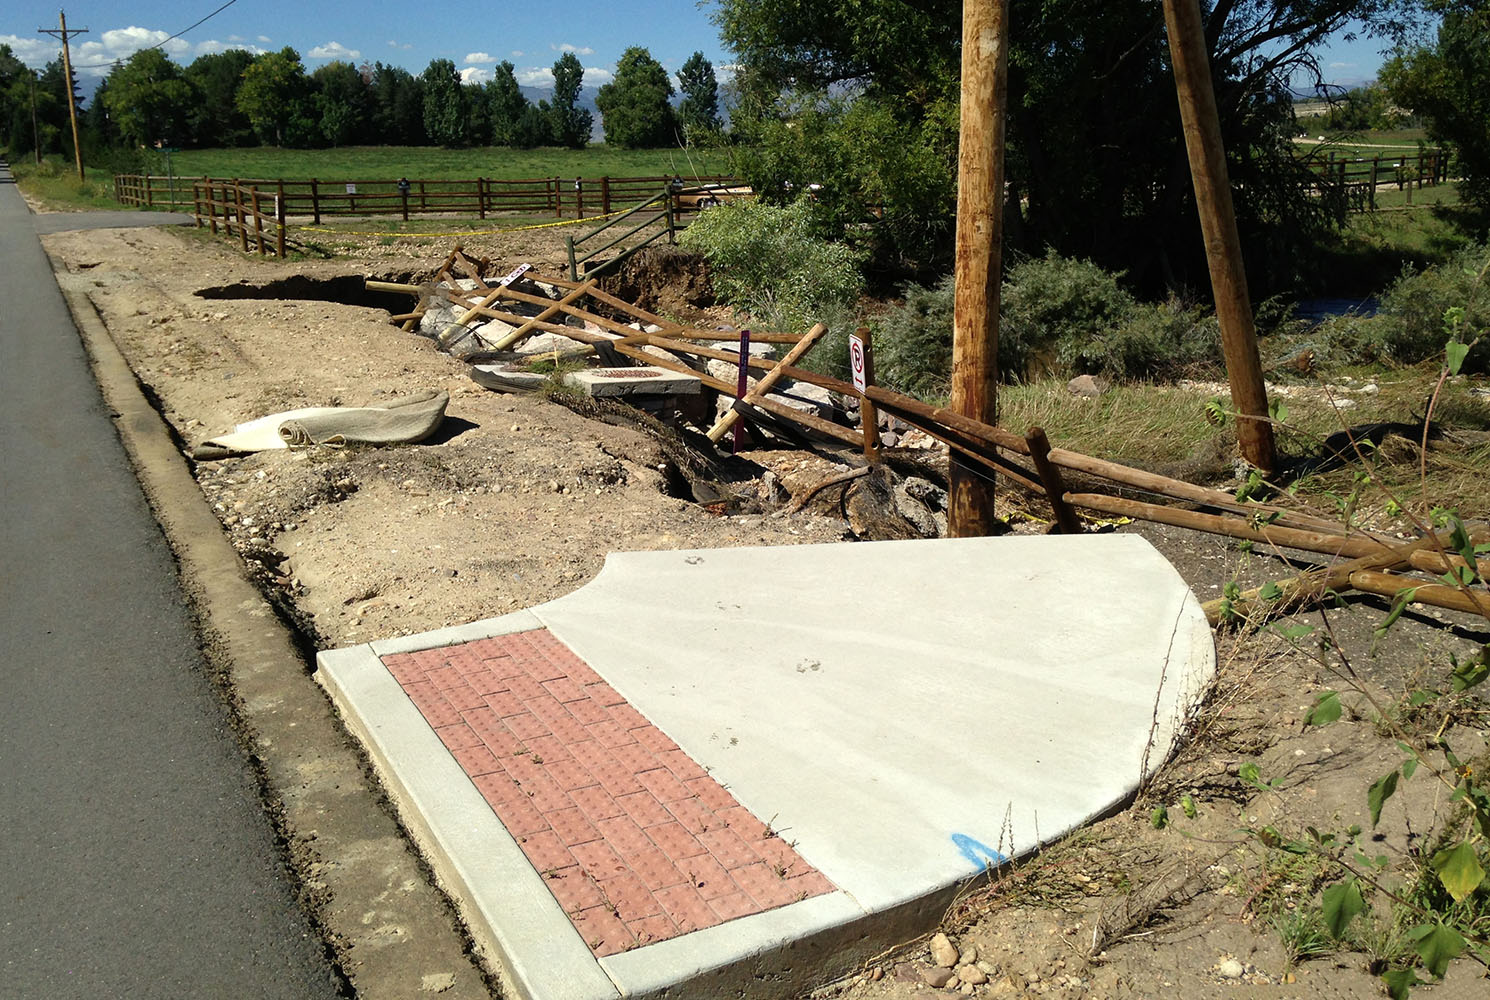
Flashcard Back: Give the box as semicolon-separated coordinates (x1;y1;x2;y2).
948;0;1009;538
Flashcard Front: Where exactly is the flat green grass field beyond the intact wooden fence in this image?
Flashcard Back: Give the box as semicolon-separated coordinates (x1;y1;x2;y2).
131;146;730;180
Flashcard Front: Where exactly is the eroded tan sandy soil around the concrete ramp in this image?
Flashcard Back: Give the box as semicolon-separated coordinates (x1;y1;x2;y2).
46;230;1487;999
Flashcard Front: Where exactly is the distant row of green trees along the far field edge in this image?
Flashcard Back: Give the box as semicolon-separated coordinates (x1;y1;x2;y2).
0;46;720;162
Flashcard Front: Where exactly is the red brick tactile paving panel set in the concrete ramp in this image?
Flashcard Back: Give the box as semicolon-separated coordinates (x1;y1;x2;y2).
383;629;833;957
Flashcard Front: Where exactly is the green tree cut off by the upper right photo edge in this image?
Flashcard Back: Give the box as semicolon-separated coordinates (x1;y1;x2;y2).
1381;0;1490;223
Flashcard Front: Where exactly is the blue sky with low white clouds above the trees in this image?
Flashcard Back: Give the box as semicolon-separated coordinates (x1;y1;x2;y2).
0;0;1381;92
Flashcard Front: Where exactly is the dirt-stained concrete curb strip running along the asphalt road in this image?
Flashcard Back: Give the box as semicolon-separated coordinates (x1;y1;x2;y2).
48;253;492;1000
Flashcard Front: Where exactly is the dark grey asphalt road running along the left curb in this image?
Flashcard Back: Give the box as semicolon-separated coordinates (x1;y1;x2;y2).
0;164;341;1000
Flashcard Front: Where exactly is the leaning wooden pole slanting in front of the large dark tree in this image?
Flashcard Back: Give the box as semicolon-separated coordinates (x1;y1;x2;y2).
1164;0;1274;472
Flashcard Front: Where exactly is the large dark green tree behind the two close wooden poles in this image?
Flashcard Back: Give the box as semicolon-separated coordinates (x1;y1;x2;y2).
717;0;1417;291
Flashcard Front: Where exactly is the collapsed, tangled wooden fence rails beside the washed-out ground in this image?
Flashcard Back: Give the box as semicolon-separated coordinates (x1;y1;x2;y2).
387;262;1490;623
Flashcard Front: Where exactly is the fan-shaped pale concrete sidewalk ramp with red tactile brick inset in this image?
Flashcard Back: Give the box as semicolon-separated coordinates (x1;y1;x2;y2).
319;535;1214;999
